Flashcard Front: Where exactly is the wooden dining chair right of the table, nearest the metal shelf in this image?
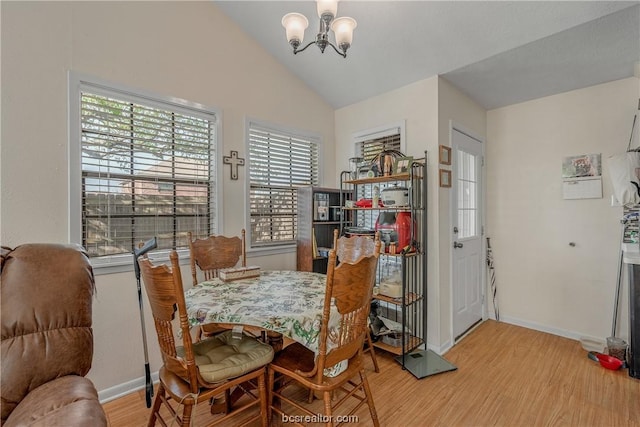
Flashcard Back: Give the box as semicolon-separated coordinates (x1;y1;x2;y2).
268;241;380;426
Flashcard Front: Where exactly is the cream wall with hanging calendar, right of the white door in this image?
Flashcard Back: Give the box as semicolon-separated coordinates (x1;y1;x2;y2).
486;78;640;339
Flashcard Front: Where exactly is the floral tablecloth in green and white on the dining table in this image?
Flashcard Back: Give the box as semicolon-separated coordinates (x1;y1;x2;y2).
185;271;339;353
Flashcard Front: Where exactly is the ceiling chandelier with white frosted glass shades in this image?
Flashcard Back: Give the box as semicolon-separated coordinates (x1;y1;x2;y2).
282;0;358;58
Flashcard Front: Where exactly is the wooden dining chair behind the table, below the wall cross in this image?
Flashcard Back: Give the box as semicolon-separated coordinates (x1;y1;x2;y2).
188;229;247;340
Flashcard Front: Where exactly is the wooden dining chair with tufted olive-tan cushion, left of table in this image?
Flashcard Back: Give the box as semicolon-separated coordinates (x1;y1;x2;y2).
139;251;273;427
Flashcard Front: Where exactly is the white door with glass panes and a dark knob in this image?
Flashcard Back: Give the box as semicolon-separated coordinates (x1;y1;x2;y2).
451;129;484;340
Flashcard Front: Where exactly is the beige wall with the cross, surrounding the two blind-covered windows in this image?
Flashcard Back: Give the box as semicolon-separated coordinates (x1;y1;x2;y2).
0;1;335;398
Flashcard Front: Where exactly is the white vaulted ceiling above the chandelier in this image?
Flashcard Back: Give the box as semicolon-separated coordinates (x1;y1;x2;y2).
214;0;640;109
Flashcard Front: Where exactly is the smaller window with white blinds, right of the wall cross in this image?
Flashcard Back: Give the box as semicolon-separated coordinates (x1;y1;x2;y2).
247;122;320;247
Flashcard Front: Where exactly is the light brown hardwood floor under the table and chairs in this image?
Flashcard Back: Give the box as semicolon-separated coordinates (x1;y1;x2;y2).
103;321;640;427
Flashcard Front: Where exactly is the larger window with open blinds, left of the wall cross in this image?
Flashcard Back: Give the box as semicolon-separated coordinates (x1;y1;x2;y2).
70;75;217;264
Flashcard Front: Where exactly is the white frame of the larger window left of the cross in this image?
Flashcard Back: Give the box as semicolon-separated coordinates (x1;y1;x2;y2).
67;71;223;275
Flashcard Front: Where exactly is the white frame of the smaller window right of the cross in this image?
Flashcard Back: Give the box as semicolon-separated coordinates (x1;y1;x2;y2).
244;117;324;255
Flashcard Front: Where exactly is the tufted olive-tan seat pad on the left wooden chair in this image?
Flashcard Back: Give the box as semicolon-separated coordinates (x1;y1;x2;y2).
177;331;274;383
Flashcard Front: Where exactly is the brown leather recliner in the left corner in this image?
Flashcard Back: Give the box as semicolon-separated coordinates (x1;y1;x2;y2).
0;244;107;427
